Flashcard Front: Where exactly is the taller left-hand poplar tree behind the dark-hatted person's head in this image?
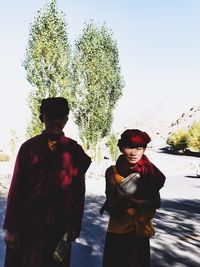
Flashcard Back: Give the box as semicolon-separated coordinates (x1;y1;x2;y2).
23;0;71;136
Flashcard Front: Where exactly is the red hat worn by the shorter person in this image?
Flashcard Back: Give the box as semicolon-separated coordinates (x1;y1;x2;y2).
118;129;151;150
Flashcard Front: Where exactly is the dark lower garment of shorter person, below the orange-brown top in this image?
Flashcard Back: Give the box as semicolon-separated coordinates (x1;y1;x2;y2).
103;232;150;267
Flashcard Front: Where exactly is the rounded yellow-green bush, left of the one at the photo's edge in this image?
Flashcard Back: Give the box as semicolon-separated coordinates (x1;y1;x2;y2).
167;129;188;150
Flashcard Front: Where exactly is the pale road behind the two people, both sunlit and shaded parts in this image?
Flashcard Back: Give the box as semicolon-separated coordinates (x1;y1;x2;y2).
0;152;200;267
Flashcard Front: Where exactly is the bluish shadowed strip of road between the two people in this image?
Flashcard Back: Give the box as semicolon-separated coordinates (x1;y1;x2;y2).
71;195;108;267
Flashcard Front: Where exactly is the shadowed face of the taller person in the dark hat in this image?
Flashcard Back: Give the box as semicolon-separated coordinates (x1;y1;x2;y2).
42;114;68;136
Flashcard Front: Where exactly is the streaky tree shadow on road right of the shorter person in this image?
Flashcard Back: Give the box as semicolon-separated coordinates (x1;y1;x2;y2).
151;199;200;267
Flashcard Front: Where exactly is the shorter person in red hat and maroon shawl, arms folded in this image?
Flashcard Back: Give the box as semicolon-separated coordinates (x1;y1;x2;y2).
101;129;165;267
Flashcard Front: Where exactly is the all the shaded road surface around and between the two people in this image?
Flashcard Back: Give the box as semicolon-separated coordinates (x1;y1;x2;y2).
0;195;200;267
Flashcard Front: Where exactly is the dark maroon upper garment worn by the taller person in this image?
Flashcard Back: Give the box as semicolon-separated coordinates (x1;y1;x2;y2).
3;132;91;237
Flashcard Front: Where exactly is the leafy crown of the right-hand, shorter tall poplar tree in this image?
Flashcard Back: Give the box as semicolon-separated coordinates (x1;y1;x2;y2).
72;22;124;152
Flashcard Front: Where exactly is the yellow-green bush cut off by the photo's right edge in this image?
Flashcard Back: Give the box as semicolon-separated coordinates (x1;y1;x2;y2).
188;122;200;152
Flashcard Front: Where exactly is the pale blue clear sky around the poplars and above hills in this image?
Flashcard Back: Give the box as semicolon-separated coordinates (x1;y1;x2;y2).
0;0;200;146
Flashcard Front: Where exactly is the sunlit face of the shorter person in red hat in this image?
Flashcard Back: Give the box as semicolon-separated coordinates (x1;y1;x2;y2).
122;147;146;165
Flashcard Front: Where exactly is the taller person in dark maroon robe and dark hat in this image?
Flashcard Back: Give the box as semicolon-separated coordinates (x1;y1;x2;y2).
3;97;91;267
